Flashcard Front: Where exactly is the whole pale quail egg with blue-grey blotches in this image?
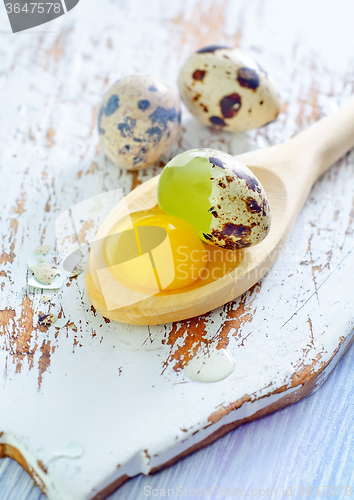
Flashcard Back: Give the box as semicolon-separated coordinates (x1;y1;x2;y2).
98;75;181;170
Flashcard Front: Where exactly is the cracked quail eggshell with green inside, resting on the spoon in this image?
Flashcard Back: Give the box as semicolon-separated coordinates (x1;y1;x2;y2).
157;149;271;250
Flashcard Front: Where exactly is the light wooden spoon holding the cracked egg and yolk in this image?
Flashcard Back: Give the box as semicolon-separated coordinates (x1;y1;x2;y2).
86;100;354;325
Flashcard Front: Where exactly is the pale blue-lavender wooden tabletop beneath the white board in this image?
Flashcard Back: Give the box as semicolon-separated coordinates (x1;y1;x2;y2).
0;348;354;500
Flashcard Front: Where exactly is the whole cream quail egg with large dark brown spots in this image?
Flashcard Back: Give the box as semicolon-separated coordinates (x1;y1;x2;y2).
178;46;281;132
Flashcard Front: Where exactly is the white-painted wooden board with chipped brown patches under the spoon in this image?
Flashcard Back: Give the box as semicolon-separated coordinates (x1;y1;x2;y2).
0;0;354;498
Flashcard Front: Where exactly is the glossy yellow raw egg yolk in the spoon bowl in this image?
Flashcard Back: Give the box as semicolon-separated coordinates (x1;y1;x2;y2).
104;209;208;293
